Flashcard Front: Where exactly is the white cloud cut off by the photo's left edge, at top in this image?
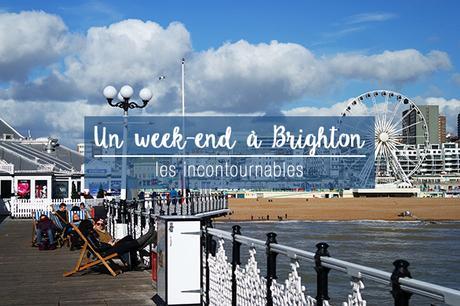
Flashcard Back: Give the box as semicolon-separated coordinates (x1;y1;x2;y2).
0;11;72;81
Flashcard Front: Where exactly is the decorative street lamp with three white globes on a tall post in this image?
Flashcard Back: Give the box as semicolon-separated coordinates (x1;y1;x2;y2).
103;85;152;200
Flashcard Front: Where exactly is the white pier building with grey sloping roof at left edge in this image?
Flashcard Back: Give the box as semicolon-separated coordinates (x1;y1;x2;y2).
0;119;84;207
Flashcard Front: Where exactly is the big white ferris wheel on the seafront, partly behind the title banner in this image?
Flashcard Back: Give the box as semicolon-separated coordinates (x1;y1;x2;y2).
341;90;429;186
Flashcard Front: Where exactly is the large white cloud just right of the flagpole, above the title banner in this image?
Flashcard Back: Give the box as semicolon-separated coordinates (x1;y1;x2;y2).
187;40;330;112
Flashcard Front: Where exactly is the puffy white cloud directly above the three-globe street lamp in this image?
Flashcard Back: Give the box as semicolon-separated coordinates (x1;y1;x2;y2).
65;19;191;97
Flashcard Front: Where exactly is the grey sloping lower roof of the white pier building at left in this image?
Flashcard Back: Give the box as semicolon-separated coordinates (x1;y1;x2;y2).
0;139;84;173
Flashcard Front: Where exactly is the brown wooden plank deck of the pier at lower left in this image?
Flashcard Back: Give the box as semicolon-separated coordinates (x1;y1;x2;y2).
0;218;155;306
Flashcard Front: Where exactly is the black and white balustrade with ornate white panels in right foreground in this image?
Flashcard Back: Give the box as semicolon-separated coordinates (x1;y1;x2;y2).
202;224;460;306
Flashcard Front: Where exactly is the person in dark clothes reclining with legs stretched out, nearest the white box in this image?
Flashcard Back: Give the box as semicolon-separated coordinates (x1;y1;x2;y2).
78;219;157;267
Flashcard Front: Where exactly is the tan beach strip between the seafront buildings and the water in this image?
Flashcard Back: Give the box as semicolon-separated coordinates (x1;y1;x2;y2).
219;198;460;221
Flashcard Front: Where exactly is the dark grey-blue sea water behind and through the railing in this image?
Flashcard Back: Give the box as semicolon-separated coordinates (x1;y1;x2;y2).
215;221;460;305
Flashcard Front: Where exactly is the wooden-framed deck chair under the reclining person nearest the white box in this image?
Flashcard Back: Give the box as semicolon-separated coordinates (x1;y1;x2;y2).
63;223;121;277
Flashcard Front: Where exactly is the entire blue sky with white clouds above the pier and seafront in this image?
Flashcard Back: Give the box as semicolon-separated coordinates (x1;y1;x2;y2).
0;0;460;146
